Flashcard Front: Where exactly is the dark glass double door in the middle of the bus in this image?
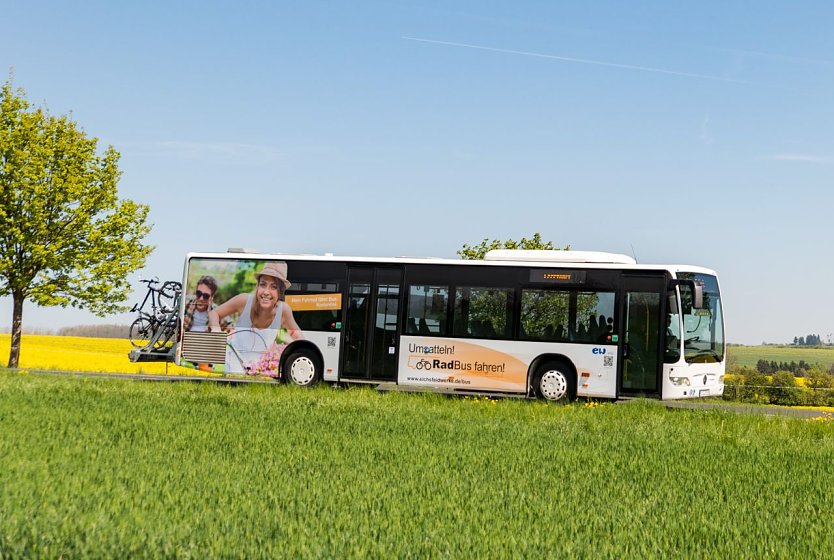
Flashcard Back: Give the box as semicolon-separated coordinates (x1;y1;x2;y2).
341;266;403;381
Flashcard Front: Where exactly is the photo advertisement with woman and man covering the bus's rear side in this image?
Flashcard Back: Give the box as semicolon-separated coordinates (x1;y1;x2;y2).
178;258;342;377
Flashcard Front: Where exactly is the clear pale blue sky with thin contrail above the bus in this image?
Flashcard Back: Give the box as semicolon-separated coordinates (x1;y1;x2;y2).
0;0;834;344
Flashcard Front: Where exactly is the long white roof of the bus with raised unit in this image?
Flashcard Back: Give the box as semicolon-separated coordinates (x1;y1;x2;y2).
186;249;716;275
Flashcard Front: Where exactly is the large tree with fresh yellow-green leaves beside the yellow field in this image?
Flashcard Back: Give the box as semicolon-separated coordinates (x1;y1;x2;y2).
0;77;153;367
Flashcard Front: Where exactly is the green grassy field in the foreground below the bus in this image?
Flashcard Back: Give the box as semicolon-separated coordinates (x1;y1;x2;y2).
0;371;834;558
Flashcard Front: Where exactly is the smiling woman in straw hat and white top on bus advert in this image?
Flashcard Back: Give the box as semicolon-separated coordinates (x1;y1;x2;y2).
209;261;304;373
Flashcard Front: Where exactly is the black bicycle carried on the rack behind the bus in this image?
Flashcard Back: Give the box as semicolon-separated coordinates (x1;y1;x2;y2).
128;277;182;350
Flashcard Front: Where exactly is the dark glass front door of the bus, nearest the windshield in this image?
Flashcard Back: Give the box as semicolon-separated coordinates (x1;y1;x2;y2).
617;274;666;396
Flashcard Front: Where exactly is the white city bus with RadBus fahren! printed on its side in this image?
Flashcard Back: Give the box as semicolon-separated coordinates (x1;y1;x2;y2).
177;250;725;401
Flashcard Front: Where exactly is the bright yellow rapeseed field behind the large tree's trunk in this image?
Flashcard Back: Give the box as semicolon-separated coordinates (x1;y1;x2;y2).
0;334;199;375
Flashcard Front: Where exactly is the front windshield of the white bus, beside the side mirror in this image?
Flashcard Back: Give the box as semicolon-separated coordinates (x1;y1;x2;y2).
678;272;724;364
